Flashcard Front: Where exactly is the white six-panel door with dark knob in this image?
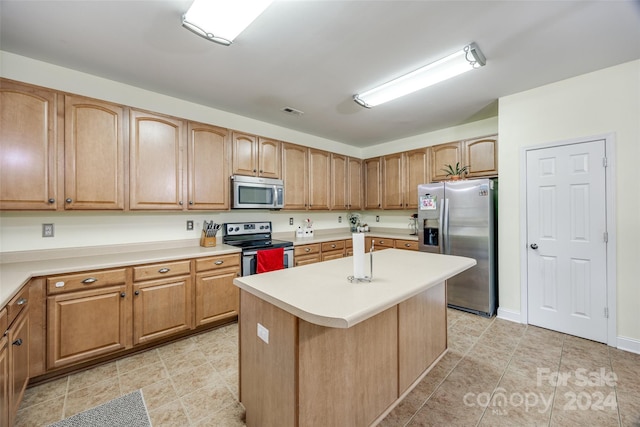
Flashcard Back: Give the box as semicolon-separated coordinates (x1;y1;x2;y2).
526;140;607;342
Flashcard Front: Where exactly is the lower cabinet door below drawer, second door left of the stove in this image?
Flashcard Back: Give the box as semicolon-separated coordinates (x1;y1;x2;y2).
133;276;193;345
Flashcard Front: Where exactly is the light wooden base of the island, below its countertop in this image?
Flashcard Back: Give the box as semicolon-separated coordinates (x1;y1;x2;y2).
240;283;447;427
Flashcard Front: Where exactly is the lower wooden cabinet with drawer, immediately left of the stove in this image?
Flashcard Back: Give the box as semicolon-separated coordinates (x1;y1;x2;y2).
195;255;240;327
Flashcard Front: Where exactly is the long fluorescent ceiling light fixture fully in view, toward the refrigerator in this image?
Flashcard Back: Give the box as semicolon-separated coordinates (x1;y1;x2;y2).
353;43;487;108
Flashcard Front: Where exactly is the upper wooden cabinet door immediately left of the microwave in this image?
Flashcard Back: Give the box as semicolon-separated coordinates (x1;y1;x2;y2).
187;122;230;210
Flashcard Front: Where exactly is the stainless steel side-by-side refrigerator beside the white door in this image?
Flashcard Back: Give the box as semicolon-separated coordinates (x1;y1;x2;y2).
418;179;498;317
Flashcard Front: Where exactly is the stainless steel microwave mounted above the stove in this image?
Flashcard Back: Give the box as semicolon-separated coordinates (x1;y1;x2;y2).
231;175;284;209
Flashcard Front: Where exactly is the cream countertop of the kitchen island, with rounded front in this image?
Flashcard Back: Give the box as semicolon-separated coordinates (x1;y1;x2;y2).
234;249;476;328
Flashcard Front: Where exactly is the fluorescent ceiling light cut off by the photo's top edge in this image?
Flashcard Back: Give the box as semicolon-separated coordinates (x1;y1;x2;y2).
182;0;273;46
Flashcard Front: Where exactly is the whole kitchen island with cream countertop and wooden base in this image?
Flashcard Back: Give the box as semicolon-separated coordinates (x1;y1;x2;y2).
234;249;475;427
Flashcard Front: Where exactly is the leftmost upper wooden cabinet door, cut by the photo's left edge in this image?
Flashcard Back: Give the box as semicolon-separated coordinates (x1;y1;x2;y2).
0;79;57;210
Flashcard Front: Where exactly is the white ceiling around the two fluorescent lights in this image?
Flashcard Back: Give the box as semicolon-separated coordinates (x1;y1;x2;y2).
0;0;640;147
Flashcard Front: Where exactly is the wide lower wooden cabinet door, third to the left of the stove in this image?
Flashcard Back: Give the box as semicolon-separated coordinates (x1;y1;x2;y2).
47;284;131;369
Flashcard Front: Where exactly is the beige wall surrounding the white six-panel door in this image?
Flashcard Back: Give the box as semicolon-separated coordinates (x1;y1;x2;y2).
498;61;640;342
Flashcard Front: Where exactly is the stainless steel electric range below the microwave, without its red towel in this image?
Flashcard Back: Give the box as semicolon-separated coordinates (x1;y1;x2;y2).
222;221;293;276
